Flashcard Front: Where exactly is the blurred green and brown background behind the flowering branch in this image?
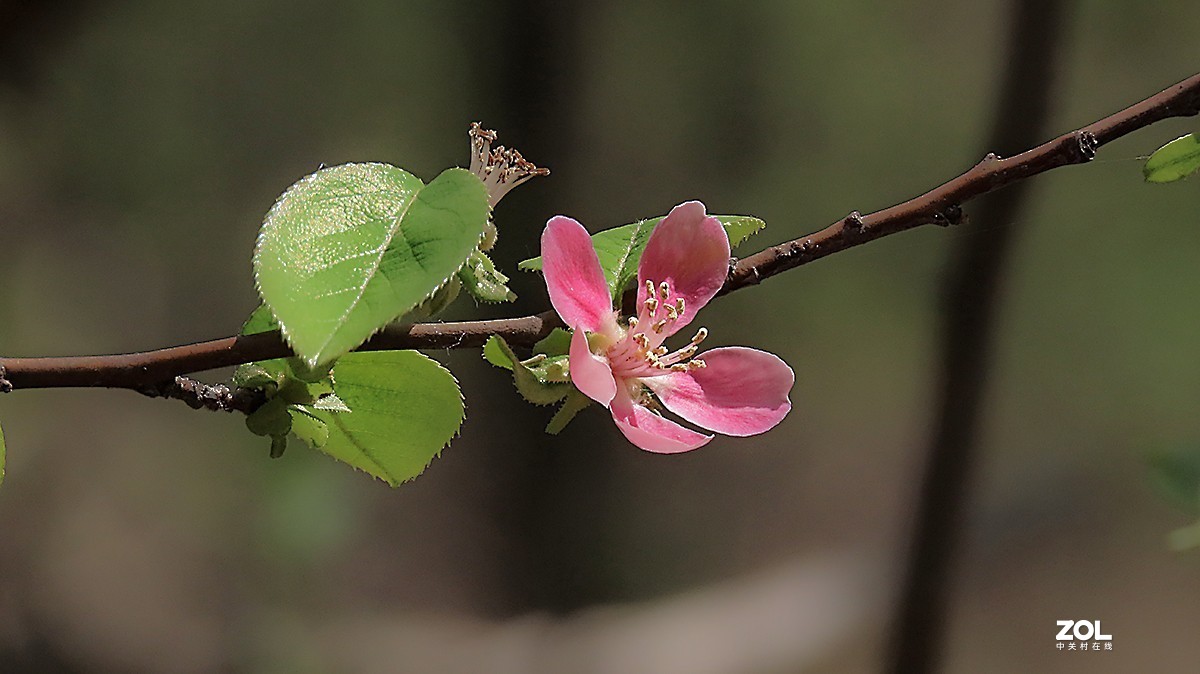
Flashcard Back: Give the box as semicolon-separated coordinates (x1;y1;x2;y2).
0;0;1200;674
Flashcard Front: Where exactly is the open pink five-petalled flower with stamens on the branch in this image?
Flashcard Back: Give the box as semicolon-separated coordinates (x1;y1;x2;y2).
541;201;796;453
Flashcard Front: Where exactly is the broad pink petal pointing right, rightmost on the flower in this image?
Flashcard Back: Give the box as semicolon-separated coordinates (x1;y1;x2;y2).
644;347;796;435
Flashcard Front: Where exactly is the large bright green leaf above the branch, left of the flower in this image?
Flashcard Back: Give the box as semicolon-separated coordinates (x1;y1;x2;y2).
254;163;488;366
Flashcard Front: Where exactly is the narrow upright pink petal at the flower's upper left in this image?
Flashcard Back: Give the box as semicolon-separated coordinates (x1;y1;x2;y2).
541;216;613;332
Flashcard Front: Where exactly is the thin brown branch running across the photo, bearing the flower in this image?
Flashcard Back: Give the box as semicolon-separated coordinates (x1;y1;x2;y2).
0;69;1200;391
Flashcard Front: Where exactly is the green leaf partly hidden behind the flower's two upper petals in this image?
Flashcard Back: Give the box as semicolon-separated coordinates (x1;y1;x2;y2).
517;216;767;297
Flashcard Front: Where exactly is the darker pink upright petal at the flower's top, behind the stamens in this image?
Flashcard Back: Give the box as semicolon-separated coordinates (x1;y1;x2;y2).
637;201;730;336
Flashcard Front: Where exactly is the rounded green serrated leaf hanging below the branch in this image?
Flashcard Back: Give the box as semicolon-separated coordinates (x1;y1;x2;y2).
305;351;463;487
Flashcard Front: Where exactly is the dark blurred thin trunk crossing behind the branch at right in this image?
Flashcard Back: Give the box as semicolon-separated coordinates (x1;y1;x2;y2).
888;0;1070;674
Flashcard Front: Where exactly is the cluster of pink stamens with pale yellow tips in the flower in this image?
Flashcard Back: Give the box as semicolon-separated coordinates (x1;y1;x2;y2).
606;279;708;378
